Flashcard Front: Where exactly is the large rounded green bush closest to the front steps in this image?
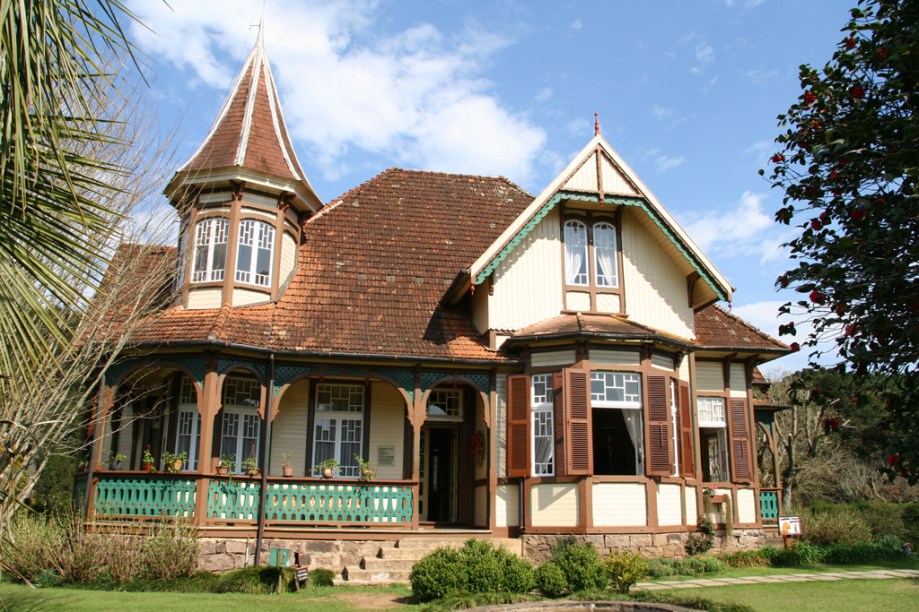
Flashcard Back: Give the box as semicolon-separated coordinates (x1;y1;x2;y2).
409;539;534;601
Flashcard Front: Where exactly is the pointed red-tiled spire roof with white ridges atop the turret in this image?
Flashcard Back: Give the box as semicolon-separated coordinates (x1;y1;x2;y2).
167;34;322;215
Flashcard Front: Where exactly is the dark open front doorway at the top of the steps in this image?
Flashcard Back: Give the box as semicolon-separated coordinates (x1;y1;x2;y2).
421;426;459;523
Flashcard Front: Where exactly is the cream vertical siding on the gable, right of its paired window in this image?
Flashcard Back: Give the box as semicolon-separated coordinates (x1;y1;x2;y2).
622;211;694;338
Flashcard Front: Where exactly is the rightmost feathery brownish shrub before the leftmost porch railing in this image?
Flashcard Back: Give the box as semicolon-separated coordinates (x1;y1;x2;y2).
141;520;201;580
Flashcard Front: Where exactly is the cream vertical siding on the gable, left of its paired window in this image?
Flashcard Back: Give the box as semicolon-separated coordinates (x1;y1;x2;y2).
488;211;562;330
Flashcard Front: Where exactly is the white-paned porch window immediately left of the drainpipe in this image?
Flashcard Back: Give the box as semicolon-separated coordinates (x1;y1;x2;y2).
220;376;262;472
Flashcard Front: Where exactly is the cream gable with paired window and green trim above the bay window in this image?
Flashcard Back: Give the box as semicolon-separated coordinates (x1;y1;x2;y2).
464;126;733;345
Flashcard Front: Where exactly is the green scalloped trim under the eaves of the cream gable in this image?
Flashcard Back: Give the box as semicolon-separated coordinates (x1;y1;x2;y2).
473;191;728;300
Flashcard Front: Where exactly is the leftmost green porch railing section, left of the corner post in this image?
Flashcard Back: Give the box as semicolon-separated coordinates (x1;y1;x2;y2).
94;476;195;518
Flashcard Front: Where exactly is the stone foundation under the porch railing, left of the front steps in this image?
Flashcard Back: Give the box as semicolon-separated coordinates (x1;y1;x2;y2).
198;538;381;574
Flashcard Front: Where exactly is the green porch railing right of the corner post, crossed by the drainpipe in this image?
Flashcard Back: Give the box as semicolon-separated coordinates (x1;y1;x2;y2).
207;481;412;523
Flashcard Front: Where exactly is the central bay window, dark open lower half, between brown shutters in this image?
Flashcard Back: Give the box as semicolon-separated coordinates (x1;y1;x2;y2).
590;372;644;476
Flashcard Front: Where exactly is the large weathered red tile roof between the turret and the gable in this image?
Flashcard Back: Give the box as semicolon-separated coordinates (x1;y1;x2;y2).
136;168;532;360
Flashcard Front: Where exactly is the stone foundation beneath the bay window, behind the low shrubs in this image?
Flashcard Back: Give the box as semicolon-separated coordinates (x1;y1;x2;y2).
521;529;781;563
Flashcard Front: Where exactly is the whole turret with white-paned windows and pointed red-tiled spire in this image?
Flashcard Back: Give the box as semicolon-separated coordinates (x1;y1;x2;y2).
166;33;322;309
